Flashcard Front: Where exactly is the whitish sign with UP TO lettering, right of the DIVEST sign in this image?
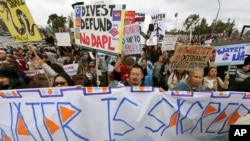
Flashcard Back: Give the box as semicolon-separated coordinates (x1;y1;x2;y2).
122;23;142;55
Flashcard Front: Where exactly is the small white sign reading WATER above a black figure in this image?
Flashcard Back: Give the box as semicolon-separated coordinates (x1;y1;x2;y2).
151;13;166;42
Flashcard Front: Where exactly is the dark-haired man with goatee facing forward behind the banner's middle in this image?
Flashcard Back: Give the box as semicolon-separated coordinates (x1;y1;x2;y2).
118;65;144;87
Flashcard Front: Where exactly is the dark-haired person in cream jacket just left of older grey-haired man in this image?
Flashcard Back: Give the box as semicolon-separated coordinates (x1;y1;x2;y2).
168;69;188;90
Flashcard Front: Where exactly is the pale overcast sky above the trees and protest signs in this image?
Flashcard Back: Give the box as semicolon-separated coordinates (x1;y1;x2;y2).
25;0;250;31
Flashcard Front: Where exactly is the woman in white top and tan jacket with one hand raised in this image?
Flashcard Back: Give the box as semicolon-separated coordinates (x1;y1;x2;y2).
202;67;229;91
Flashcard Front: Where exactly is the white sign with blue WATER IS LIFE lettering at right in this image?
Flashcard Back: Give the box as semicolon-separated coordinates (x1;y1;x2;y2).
215;44;247;66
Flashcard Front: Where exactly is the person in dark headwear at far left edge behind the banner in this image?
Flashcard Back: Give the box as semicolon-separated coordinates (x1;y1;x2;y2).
0;68;28;90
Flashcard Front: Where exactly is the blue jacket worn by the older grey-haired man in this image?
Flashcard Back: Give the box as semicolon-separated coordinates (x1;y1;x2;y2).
171;78;204;92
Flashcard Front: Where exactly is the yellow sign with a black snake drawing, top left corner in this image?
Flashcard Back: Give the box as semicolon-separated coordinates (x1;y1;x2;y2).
0;0;42;42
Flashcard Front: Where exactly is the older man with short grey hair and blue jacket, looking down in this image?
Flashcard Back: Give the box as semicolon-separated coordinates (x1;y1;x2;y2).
171;68;204;92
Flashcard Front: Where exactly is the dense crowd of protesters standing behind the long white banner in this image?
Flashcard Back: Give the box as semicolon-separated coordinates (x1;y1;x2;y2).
0;37;250;91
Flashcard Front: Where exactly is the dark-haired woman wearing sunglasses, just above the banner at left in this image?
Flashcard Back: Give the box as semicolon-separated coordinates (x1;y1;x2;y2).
53;73;75;87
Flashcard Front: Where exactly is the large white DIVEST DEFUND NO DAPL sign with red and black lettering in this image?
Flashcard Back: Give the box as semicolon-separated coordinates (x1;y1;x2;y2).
74;4;125;54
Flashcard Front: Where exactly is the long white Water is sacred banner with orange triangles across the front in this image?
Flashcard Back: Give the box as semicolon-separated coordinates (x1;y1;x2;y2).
0;87;250;141
